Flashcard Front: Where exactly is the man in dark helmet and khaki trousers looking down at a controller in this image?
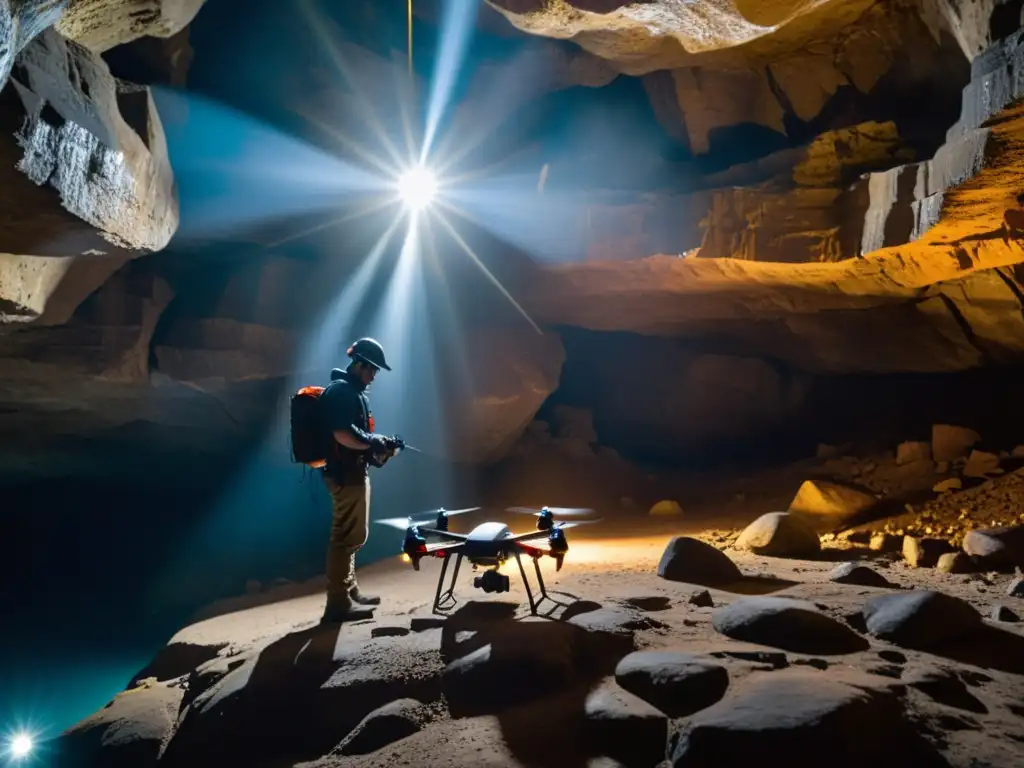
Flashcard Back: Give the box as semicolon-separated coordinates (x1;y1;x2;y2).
319;338;398;624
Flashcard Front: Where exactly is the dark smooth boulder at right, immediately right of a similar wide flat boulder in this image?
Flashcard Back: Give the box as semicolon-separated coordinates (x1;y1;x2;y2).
862;590;982;649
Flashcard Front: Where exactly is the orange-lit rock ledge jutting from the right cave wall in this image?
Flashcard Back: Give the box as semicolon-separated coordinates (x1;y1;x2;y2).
526;28;1024;376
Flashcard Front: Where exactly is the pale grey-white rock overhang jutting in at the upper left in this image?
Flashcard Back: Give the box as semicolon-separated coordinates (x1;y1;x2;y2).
0;29;178;324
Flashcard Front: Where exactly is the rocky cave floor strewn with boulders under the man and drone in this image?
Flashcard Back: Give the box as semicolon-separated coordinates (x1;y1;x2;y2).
52;425;1024;768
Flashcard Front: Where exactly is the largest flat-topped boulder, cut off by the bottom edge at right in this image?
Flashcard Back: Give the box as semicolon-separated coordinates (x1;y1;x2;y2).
672;670;946;768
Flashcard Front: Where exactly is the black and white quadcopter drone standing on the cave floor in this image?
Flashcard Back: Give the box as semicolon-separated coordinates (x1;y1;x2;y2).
377;507;598;615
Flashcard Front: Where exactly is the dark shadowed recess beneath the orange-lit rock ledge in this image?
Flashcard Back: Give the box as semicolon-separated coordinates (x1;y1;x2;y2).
538;328;1024;469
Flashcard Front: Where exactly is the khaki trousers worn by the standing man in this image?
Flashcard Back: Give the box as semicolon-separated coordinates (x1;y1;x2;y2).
324;475;370;602
